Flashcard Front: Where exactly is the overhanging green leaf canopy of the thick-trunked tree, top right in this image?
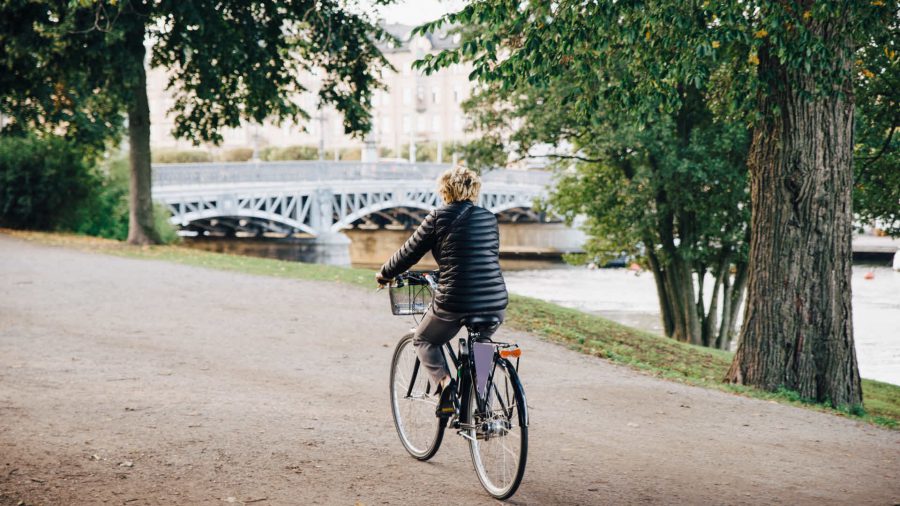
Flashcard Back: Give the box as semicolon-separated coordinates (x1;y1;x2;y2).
417;0;897;120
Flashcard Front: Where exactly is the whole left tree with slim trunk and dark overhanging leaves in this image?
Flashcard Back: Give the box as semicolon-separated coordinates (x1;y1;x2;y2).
0;0;386;244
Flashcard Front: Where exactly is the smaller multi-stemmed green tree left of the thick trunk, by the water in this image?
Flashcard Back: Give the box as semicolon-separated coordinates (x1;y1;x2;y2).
464;79;749;349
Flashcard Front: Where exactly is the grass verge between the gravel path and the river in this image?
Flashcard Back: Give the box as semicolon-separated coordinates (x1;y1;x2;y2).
0;229;900;428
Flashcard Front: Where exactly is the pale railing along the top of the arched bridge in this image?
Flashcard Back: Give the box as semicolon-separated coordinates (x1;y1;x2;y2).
153;161;551;187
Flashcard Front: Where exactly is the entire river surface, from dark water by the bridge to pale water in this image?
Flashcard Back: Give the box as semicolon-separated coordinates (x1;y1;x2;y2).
185;235;900;385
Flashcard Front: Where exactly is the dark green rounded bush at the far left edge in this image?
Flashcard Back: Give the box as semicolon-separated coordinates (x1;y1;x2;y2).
0;136;98;230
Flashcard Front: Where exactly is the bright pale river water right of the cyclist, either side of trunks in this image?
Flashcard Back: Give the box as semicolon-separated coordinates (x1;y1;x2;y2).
504;265;900;385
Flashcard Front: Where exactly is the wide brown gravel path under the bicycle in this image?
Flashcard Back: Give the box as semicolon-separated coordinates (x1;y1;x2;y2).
0;235;900;505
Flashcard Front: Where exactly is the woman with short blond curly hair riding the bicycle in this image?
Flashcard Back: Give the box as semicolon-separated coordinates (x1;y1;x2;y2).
375;167;508;416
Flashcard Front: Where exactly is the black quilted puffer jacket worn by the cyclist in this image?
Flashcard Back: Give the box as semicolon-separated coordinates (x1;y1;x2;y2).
381;200;508;313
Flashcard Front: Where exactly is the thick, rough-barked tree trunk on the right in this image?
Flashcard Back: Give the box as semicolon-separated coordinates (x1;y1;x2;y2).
727;24;862;407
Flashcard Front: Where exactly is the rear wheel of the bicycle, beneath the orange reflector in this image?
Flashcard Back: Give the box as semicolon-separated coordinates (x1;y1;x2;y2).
466;359;528;499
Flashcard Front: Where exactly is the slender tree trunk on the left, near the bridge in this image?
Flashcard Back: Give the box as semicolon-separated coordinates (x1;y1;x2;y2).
128;21;160;244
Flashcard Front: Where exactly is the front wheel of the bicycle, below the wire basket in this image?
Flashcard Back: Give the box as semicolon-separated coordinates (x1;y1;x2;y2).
391;332;444;460
